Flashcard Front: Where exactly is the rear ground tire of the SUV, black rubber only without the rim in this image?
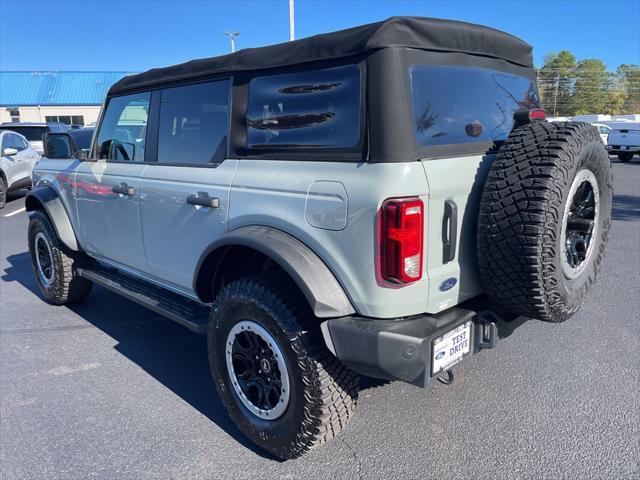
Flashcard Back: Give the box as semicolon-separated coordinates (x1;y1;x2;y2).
207;272;359;459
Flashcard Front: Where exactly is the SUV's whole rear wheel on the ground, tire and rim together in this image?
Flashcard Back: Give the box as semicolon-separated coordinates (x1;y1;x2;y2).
208;273;358;459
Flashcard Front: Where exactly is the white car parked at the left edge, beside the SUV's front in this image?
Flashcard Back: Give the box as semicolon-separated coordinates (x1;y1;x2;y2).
0;130;40;208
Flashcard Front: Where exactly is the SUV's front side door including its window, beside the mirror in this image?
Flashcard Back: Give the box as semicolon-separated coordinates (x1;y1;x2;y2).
73;93;151;272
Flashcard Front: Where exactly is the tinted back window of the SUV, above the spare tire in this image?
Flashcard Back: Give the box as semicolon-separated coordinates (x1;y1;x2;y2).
411;66;540;146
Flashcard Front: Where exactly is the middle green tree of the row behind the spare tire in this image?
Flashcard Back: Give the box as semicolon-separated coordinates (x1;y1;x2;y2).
567;58;612;115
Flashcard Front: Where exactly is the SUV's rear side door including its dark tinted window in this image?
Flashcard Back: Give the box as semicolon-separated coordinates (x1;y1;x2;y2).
140;79;237;293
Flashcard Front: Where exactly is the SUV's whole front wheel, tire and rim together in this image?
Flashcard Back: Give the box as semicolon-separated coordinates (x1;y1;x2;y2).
28;211;93;305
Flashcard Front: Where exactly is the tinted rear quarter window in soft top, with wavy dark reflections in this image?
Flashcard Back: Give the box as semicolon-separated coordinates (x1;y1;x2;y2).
247;65;360;148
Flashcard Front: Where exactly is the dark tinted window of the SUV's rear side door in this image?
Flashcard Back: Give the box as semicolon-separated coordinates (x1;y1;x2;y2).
158;80;230;165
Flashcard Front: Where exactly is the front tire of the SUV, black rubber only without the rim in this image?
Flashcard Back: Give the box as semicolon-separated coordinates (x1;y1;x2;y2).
28;211;93;305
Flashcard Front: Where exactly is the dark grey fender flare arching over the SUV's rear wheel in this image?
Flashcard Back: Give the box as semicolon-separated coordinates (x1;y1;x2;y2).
194;226;355;318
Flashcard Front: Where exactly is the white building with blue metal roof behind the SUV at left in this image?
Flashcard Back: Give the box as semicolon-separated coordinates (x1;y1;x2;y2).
0;72;132;125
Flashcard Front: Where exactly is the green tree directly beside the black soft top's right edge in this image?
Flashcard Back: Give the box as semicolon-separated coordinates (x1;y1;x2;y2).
538;50;576;115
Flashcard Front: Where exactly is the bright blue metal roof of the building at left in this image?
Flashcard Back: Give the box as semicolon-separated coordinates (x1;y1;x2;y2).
0;71;132;107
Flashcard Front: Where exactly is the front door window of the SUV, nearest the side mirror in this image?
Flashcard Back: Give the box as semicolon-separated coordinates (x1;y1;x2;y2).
97;92;151;162
